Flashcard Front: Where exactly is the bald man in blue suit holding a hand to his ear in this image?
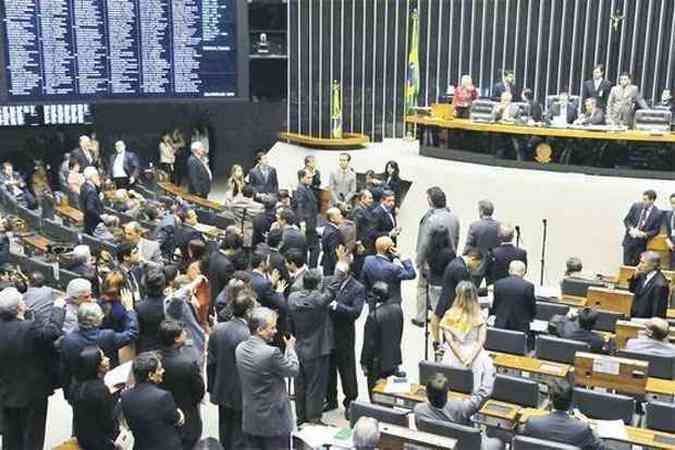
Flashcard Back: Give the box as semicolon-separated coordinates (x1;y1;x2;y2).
361;236;417;303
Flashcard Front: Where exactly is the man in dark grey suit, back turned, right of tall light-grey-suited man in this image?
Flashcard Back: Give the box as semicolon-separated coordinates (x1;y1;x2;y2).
462;200;501;288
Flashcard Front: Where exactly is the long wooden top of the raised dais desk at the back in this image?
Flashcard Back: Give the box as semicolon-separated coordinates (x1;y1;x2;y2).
405;115;675;144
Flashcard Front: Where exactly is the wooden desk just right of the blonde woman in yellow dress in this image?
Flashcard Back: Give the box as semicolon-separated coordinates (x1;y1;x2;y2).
493;353;572;391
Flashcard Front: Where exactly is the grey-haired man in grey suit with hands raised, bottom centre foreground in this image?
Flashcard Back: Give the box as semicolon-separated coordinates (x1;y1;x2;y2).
235;307;302;450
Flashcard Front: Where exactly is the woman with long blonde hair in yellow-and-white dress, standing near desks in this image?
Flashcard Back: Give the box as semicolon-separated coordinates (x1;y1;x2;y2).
440;281;494;389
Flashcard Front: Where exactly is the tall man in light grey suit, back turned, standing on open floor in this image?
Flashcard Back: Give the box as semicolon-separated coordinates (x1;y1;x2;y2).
413;186;459;326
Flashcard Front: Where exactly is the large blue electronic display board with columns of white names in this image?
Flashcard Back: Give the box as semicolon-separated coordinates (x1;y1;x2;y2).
0;0;239;102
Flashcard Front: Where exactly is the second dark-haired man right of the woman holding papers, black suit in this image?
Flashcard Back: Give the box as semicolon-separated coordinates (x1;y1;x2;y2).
159;320;204;450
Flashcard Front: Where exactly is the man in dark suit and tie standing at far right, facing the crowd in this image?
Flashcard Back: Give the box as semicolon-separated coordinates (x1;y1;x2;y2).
623;189;662;266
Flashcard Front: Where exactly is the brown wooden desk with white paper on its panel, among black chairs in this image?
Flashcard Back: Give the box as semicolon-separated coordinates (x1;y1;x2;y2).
574;352;649;395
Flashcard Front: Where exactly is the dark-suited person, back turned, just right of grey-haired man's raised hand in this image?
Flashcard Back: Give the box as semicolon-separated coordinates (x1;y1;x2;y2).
136;270;166;355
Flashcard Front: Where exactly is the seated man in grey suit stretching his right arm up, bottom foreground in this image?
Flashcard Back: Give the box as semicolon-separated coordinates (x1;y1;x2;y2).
413;373;504;450
